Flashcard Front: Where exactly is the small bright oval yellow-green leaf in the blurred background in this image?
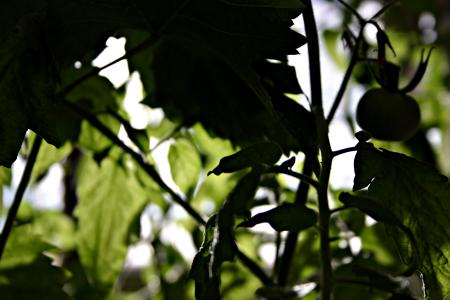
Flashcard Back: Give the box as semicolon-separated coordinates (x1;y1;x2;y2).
169;138;202;193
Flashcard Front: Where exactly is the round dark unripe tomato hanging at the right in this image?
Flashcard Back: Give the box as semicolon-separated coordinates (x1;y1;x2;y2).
356;88;420;141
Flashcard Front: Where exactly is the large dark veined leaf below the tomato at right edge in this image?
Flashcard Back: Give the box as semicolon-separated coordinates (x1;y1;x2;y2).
353;148;450;299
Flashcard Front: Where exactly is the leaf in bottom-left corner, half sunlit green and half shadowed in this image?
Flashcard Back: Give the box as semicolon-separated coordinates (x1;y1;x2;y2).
0;225;68;300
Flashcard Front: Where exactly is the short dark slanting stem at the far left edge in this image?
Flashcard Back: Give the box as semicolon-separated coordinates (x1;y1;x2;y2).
0;135;42;259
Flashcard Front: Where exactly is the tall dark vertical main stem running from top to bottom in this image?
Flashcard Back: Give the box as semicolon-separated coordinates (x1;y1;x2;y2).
303;0;333;300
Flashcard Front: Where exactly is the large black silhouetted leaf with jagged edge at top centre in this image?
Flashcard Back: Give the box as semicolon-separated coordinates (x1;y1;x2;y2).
132;0;305;152
